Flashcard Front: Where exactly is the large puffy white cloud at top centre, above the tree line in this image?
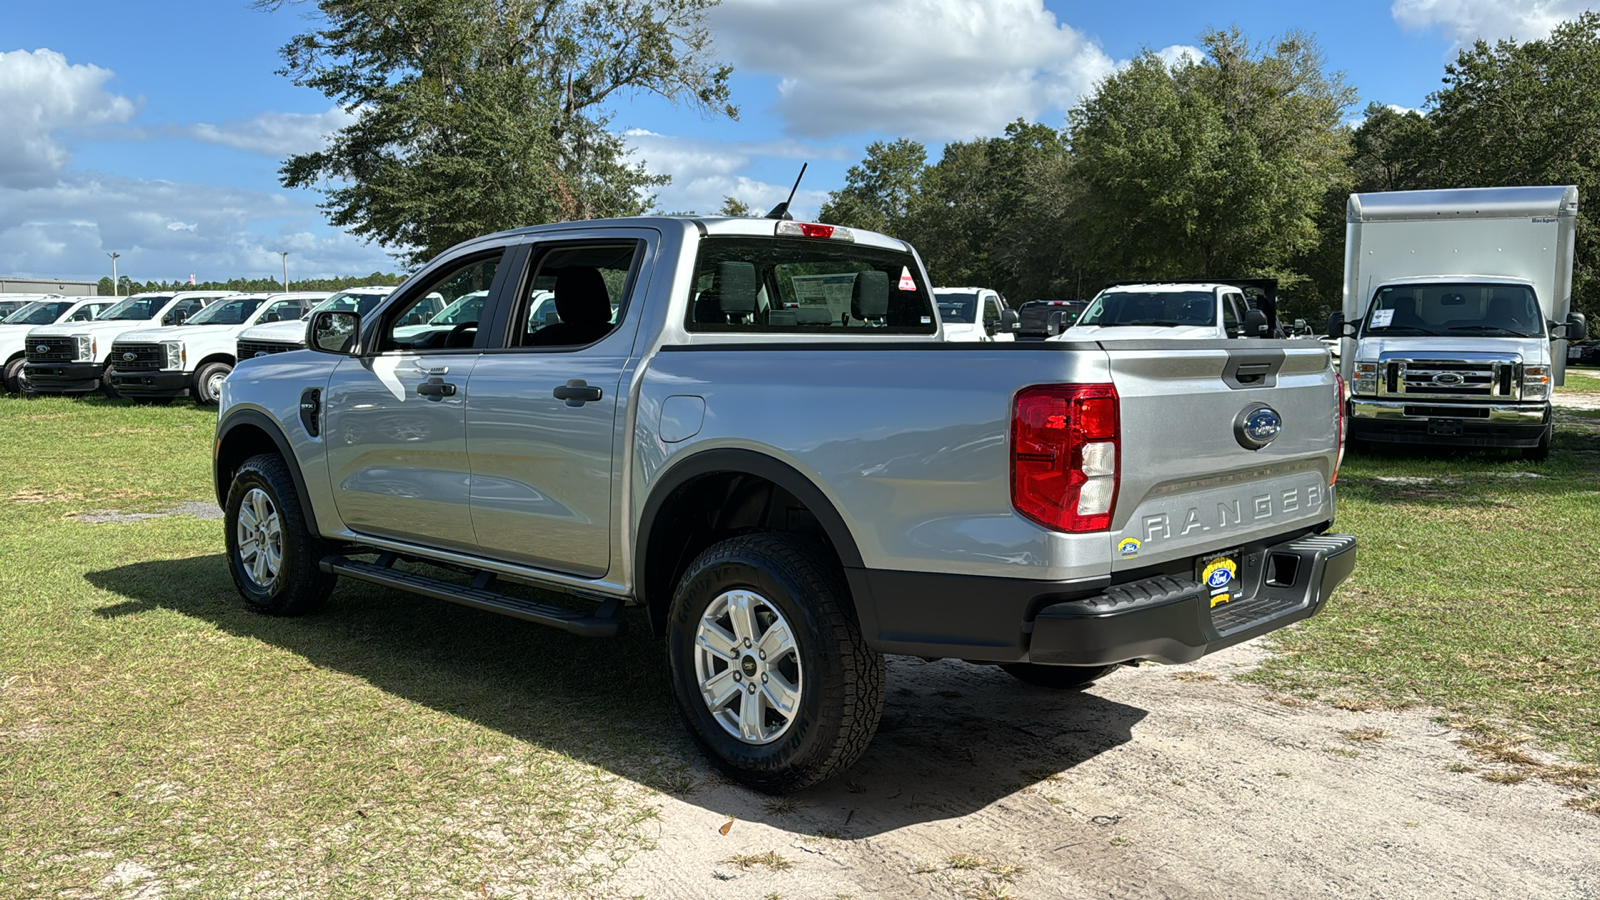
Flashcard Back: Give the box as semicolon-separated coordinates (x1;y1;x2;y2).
710;0;1114;141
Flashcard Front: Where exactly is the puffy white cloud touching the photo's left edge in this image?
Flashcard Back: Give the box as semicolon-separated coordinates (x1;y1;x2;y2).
0;50;134;187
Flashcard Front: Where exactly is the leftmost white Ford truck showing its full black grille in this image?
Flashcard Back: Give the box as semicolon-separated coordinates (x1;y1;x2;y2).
24;291;232;397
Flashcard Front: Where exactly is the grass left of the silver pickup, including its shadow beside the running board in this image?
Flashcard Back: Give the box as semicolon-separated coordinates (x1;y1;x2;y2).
0;397;693;898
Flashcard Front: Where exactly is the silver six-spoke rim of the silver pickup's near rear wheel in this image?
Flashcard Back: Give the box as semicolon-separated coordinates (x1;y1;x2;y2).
694;591;805;745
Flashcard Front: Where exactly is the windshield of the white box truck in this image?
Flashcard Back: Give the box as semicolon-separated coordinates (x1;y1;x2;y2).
1362;282;1544;338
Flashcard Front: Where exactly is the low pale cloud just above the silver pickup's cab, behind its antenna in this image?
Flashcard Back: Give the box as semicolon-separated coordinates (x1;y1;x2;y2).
624;128;851;218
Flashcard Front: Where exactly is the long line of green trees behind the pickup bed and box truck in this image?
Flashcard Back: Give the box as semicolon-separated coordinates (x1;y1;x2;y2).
819;11;1600;323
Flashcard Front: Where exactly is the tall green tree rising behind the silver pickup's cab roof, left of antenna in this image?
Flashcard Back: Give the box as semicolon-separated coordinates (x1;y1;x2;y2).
256;0;738;263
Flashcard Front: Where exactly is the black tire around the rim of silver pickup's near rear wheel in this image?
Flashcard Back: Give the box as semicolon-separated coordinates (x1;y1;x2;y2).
667;533;885;793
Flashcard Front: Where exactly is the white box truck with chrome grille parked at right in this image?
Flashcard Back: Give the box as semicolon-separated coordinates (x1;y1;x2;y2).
1328;186;1586;460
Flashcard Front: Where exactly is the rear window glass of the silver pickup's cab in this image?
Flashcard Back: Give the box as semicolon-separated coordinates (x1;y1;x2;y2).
686;237;934;335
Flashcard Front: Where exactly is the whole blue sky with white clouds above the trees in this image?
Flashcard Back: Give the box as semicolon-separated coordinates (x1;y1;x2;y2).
0;0;1589;280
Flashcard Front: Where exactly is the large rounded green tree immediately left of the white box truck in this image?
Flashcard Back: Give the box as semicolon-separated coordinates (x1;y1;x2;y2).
1069;29;1355;288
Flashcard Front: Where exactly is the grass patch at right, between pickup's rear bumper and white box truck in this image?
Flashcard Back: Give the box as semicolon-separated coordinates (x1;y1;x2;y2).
1251;375;1600;802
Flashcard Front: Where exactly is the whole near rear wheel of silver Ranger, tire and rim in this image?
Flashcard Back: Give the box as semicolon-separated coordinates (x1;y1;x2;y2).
667;533;883;793
